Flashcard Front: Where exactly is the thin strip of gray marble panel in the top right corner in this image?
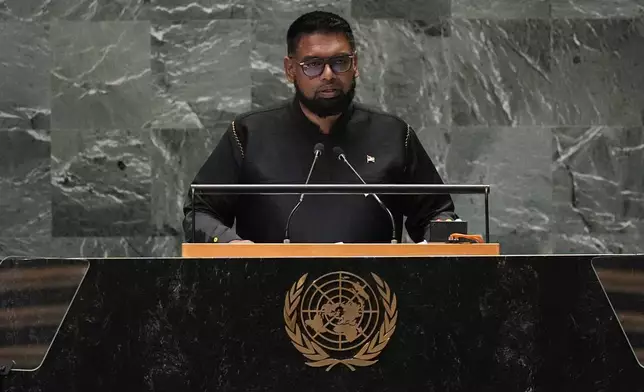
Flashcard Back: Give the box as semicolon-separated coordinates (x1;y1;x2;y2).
550;0;644;19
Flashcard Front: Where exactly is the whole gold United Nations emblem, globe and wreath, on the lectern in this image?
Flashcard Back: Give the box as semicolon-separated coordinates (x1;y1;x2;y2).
284;271;398;371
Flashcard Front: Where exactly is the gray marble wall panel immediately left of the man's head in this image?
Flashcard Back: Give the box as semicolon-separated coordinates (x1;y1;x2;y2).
250;19;295;109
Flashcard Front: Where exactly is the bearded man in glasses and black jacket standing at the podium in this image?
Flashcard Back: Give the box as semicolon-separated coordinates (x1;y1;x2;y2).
183;11;457;243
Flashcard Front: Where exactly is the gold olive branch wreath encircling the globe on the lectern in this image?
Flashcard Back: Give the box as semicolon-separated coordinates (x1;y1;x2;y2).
284;273;398;371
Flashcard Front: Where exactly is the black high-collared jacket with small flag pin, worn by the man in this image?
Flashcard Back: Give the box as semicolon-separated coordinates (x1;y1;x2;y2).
183;100;456;243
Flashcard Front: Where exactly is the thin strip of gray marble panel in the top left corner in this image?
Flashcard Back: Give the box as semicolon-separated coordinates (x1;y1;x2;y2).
0;0;147;21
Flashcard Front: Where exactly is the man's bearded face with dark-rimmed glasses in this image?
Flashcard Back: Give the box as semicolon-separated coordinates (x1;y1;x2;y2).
284;33;358;117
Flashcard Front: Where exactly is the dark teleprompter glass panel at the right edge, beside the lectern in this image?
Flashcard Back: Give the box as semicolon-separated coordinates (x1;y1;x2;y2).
592;255;644;367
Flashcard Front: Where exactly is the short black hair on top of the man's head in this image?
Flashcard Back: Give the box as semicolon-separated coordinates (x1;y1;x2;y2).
286;11;355;56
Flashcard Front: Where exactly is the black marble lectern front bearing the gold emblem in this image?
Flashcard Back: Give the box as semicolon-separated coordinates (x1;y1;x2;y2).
4;256;644;392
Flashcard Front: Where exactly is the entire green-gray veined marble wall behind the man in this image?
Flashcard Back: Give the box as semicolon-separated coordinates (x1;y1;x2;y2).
0;0;644;257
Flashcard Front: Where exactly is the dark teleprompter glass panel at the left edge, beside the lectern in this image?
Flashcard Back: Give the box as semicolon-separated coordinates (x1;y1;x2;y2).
0;258;89;371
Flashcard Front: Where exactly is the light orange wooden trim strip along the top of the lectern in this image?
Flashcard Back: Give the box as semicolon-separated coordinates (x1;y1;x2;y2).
181;243;501;258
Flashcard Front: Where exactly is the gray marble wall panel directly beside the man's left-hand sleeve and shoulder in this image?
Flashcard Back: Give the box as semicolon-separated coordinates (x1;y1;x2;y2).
151;124;232;237
